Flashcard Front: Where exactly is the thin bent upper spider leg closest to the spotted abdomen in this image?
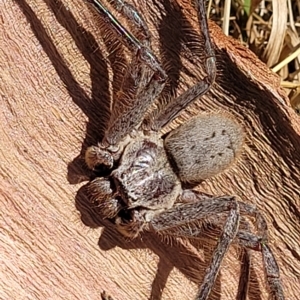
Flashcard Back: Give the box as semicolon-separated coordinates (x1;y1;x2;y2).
146;0;216;131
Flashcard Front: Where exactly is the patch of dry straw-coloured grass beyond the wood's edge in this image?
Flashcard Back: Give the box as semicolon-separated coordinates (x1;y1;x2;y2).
208;0;300;111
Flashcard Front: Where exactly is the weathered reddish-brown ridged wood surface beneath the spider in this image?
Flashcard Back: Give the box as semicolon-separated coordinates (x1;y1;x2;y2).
0;0;300;300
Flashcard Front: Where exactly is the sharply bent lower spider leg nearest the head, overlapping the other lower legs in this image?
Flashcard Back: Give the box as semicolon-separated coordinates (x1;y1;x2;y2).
149;196;240;300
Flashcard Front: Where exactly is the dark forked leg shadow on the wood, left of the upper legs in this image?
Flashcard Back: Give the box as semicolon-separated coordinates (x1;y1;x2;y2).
15;0;110;184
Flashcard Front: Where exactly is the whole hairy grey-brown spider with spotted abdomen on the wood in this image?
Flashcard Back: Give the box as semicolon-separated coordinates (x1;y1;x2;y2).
85;0;284;300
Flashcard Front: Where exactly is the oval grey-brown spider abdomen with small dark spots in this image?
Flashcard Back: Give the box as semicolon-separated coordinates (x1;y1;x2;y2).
164;113;245;183
